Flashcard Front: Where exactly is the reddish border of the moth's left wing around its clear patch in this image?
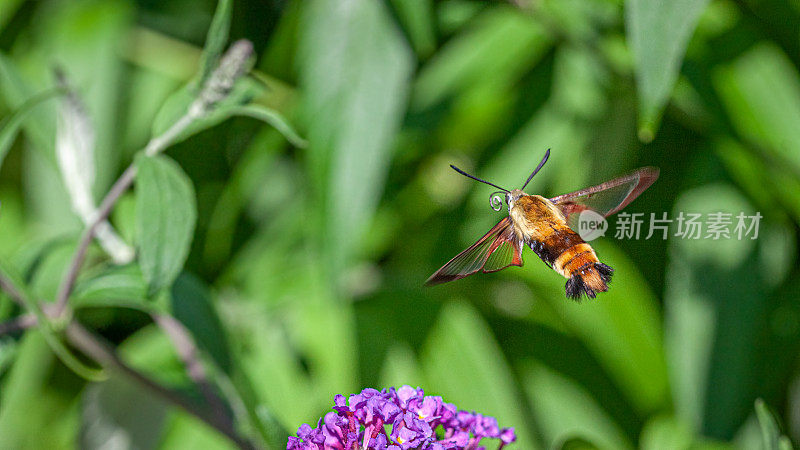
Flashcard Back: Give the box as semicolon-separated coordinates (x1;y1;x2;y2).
425;217;522;286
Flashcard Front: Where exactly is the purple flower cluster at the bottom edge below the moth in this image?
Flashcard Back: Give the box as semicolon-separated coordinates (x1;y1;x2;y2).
286;386;516;450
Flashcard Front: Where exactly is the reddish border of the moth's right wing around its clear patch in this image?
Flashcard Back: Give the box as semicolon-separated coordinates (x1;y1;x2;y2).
550;167;659;218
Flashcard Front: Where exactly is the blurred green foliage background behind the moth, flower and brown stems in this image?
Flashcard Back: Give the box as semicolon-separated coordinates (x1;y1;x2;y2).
0;0;800;450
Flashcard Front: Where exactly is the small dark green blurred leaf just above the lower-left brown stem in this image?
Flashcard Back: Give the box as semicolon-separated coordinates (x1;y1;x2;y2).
171;273;233;374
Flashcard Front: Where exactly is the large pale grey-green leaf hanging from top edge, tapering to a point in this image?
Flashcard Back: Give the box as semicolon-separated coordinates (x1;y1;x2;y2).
300;0;412;271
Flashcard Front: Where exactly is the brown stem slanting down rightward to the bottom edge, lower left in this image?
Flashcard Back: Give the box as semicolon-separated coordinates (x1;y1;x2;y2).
65;321;255;450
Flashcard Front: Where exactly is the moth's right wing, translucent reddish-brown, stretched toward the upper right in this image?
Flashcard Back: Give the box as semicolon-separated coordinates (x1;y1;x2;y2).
550;167;658;229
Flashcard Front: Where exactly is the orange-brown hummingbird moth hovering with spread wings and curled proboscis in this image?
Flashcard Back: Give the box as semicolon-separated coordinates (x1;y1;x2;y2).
425;149;658;299
